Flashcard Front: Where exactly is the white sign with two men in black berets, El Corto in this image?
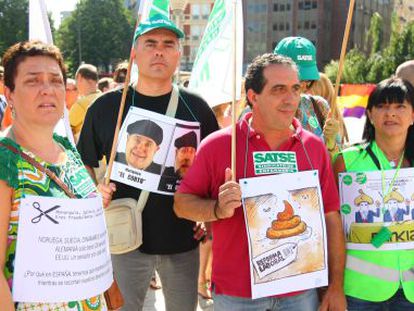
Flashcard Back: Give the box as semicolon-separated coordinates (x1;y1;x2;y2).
111;107;200;195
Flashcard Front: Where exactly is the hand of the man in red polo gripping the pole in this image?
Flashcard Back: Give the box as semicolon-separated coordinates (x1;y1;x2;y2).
215;168;241;219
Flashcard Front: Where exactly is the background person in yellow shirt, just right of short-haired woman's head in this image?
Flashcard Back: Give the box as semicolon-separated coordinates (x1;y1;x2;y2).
69;64;101;140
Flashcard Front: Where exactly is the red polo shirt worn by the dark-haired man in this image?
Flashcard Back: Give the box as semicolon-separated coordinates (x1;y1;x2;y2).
178;113;339;298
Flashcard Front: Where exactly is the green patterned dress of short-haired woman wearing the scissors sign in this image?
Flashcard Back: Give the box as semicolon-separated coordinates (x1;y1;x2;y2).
0;135;107;311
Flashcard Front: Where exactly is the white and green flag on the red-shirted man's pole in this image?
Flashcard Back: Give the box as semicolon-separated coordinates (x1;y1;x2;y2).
188;0;243;107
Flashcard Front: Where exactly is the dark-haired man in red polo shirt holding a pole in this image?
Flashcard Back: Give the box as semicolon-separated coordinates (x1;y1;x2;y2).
174;54;346;311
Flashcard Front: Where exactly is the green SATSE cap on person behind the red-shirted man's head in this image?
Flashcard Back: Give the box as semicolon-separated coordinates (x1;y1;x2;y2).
273;37;319;81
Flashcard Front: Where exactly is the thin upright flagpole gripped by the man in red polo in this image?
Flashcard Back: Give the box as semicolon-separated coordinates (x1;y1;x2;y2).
231;0;237;181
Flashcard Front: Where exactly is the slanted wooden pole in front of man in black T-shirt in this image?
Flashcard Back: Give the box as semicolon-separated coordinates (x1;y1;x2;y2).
105;13;142;185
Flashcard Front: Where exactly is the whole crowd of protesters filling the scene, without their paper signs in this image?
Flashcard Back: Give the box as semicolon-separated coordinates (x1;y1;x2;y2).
0;15;414;311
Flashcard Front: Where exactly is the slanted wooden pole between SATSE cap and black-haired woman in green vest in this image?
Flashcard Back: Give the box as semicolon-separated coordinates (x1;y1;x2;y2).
330;0;355;140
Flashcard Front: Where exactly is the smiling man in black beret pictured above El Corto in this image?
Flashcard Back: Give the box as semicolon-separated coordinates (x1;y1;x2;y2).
115;120;163;174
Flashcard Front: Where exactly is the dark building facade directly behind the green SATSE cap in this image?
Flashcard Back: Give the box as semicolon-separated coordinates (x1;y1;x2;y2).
243;0;349;70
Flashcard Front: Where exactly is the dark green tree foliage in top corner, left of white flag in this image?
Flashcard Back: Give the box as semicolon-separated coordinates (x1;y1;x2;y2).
0;0;29;57
